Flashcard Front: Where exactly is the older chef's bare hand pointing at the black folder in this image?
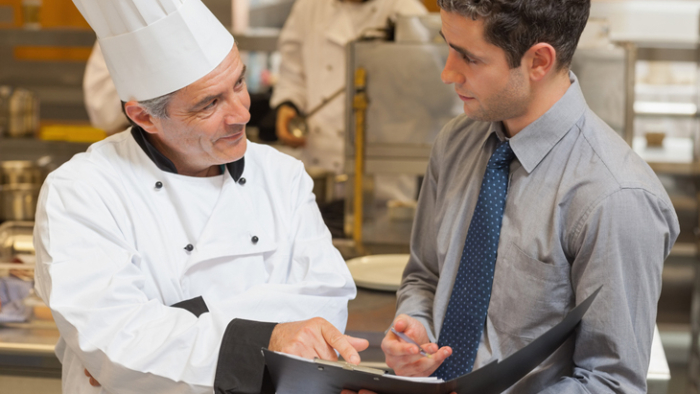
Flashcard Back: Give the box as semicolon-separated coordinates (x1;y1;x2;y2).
268;317;369;365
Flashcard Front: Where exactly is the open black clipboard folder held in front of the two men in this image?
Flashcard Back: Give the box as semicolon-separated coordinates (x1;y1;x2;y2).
263;288;600;394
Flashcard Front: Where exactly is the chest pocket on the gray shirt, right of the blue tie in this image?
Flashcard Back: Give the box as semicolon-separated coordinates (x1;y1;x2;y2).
488;243;573;339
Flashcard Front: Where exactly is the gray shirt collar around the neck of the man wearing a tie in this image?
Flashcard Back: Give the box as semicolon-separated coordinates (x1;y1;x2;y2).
491;71;588;174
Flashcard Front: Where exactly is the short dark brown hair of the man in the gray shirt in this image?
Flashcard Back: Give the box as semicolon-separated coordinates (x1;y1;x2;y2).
437;0;591;70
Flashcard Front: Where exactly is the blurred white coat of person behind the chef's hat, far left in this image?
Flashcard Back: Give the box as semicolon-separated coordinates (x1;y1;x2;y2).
83;43;129;135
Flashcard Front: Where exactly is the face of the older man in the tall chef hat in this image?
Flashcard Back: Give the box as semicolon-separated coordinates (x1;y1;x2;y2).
154;46;250;173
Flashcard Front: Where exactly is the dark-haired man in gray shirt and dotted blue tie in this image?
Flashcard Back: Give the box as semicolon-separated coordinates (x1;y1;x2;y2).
344;0;679;393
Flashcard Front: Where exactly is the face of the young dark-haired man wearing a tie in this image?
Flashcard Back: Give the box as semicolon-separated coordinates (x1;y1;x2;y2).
440;11;530;122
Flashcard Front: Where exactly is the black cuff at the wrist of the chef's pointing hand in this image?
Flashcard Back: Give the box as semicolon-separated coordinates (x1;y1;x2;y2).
214;319;277;394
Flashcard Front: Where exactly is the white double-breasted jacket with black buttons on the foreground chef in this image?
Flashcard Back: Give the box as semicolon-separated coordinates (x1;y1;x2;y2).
34;129;356;394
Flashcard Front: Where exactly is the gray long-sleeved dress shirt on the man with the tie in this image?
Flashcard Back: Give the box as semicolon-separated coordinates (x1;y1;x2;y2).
397;73;679;393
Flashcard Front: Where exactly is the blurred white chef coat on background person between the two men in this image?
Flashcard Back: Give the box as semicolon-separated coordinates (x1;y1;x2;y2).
270;0;427;198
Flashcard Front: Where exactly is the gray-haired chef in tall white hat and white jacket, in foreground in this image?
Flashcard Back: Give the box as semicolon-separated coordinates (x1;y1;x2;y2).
34;0;367;394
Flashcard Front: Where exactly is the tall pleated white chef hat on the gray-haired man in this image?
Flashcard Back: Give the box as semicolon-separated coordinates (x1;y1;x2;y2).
73;0;233;101
